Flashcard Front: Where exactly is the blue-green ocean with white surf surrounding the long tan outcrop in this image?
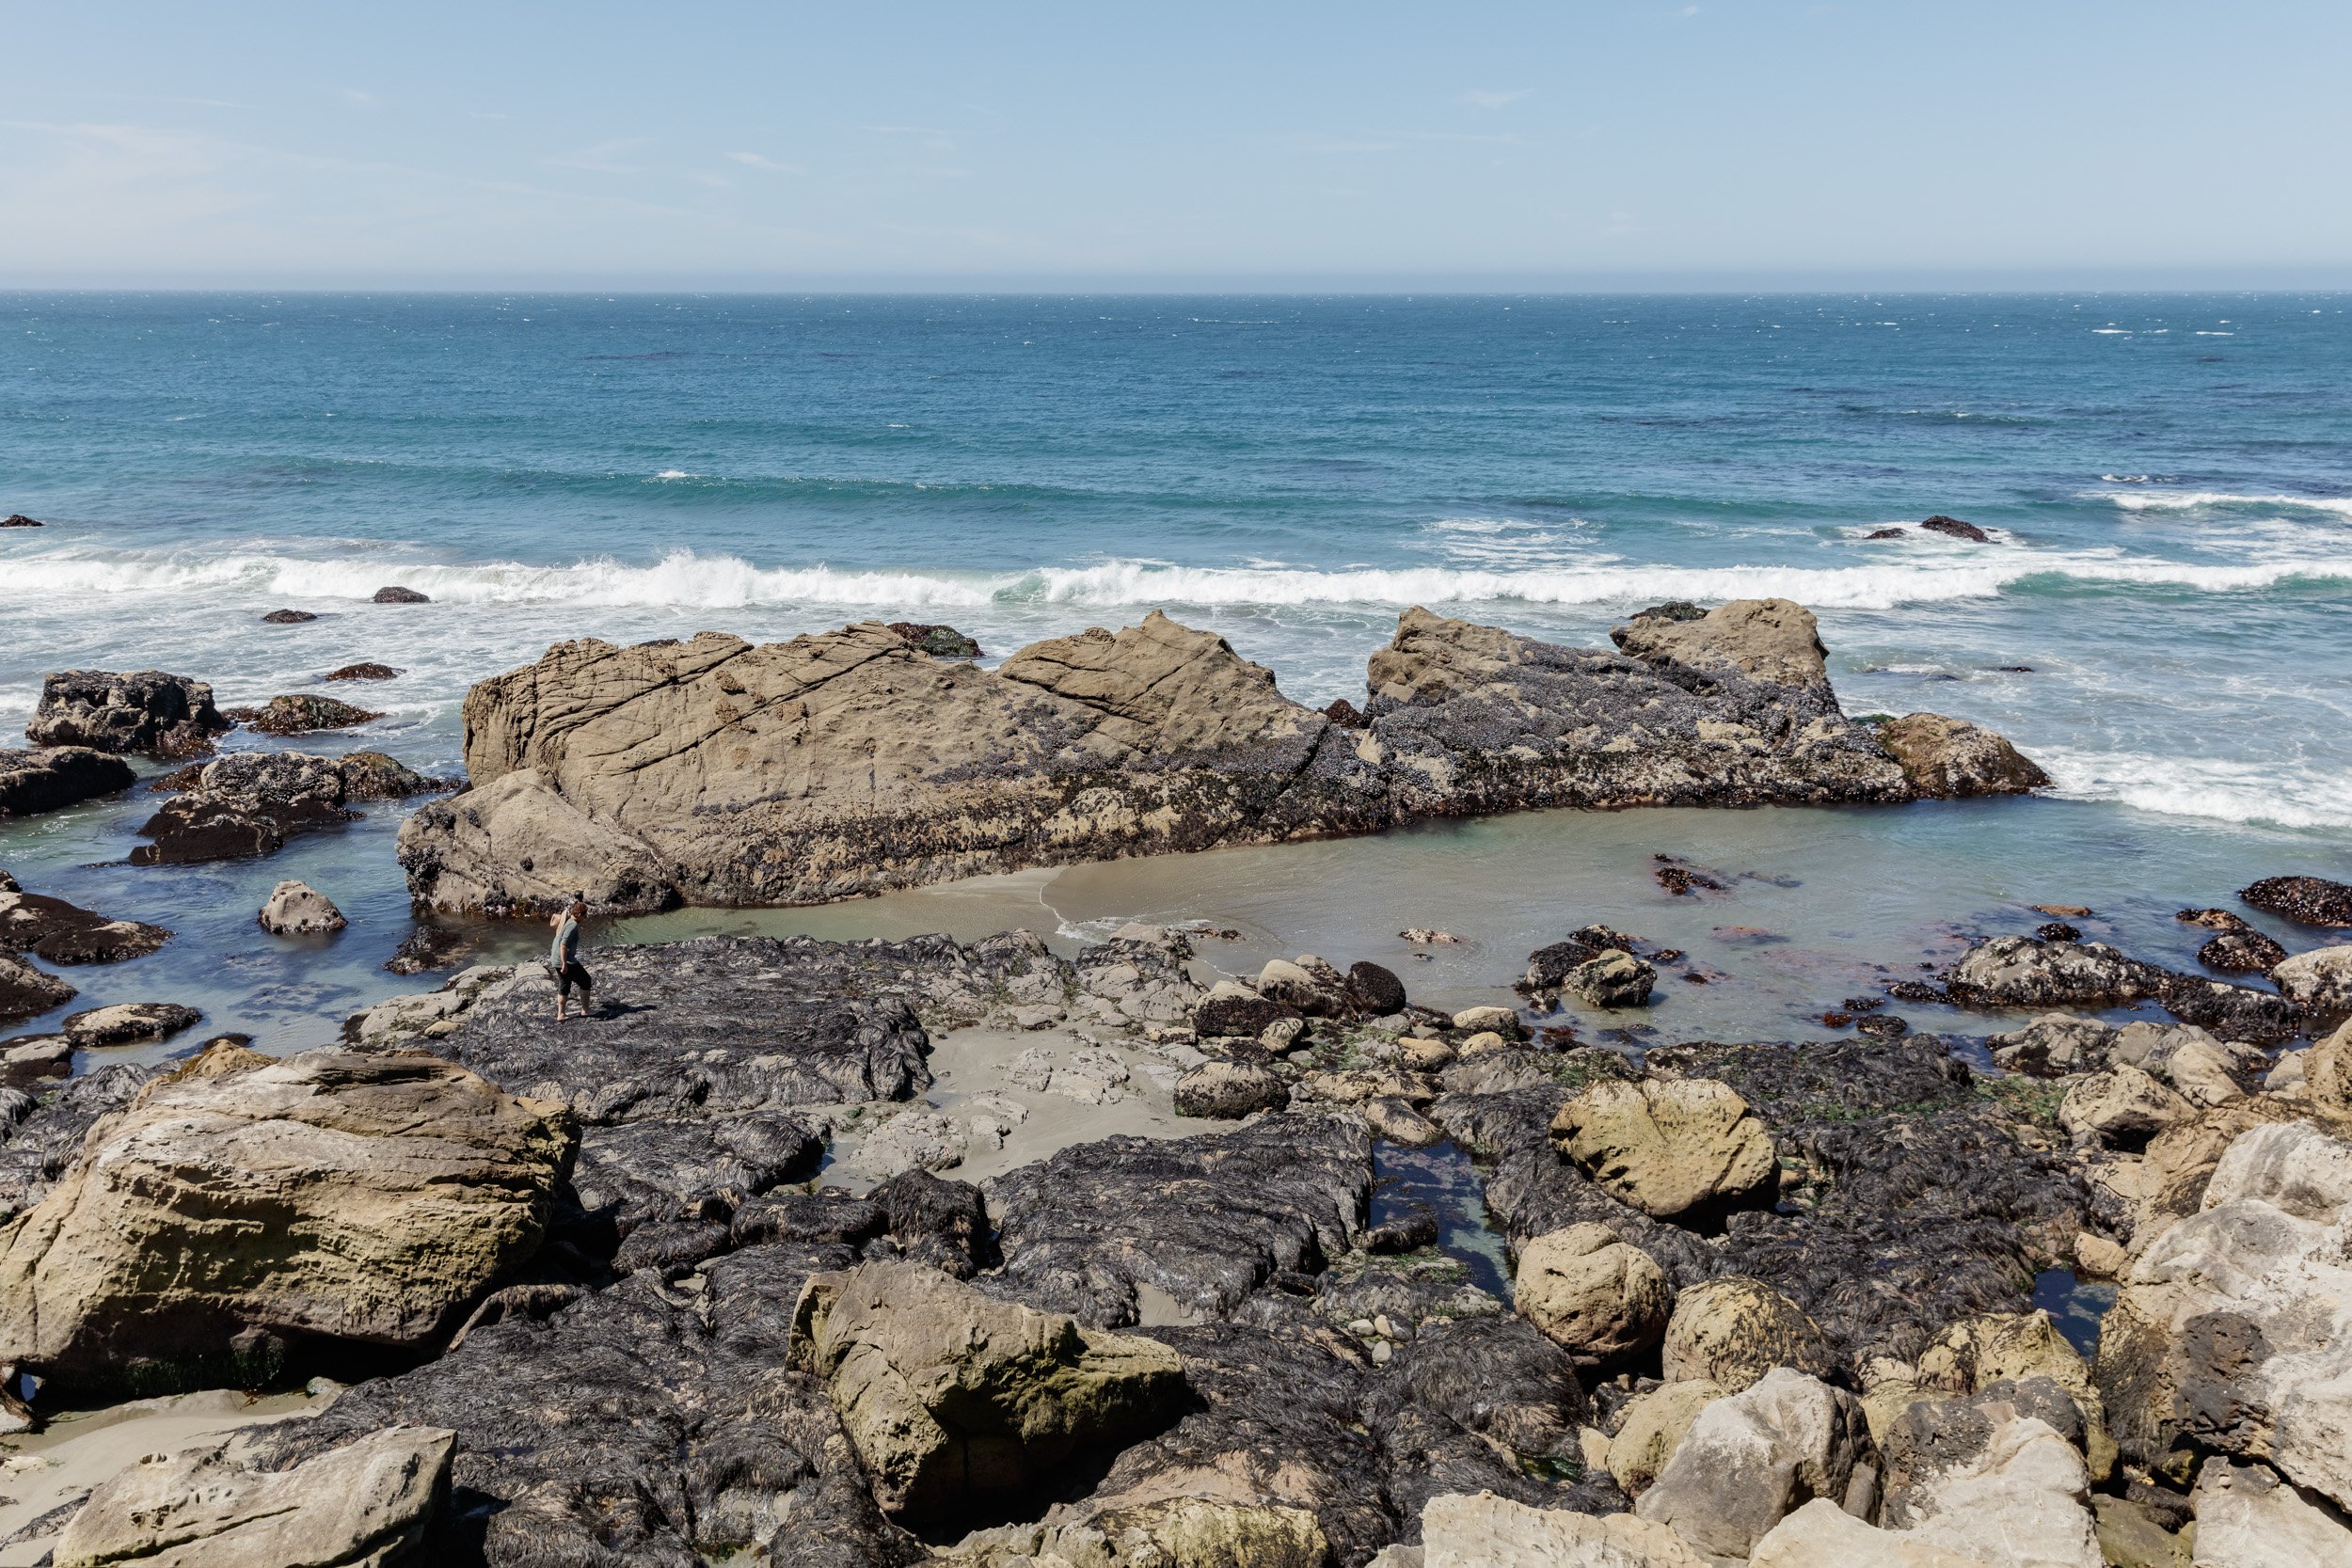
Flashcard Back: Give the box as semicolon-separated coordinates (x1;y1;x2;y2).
0;293;2352;1055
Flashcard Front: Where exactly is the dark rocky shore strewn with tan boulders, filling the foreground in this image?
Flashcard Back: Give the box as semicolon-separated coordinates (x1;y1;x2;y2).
0;860;2352;1568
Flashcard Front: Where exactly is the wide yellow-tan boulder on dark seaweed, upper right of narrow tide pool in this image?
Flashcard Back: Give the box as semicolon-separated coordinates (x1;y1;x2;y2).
1552;1079;1781;1227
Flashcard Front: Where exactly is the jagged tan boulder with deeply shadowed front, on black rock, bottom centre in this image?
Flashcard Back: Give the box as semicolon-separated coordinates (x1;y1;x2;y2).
793;1262;1184;1521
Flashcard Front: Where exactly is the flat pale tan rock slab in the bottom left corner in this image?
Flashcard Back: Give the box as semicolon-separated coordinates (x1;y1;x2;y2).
50;1427;454;1568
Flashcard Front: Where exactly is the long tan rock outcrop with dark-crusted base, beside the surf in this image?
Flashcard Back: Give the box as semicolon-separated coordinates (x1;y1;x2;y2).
400;599;2032;912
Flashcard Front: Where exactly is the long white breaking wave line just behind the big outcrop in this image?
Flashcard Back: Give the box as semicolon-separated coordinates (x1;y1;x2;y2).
0;543;2352;609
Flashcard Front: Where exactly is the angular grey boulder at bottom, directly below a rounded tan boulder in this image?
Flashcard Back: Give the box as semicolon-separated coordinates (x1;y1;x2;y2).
1635;1366;1872;1563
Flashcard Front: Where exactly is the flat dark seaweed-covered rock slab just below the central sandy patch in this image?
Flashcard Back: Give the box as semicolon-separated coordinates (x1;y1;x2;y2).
986;1110;1372;1328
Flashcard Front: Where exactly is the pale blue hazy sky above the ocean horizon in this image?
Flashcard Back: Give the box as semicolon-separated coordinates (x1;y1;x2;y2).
0;0;2352;287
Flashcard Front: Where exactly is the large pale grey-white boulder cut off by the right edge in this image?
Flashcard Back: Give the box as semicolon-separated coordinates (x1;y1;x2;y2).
2096;1121;2352;1507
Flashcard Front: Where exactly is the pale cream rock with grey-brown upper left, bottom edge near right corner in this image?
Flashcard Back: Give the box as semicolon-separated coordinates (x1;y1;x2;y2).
1880;1385;2106;1568
